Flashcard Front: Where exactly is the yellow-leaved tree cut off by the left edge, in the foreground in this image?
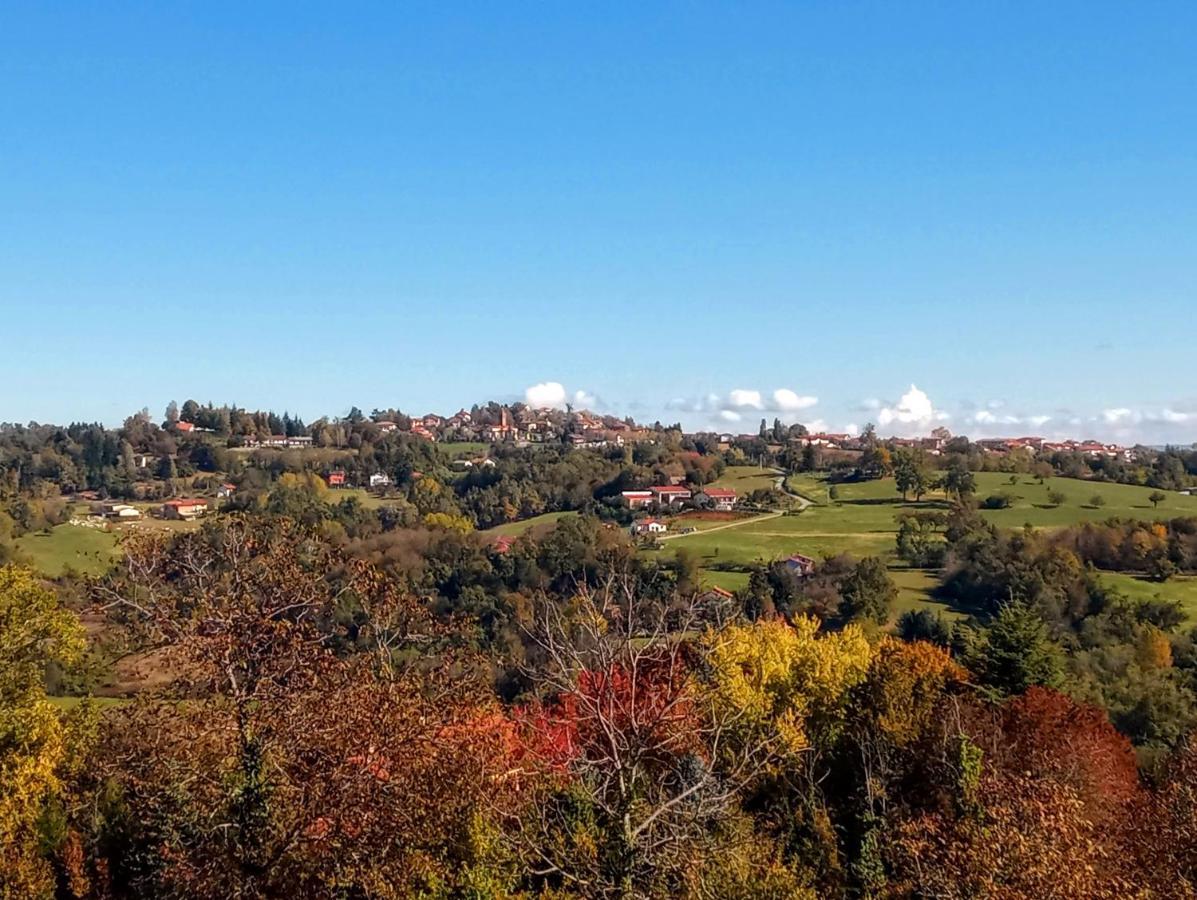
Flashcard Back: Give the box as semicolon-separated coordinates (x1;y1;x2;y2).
0;566;84;898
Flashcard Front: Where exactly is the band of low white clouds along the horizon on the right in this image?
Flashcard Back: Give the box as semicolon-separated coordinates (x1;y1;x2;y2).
523;381;1197;444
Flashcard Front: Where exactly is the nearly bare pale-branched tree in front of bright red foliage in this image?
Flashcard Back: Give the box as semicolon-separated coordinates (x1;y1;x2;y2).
514;574;794;898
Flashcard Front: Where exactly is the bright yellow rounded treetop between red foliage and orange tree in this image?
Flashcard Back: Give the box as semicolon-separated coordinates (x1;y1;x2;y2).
704;616;873;755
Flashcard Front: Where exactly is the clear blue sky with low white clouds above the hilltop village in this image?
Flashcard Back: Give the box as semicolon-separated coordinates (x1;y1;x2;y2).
0;2;1197;442
